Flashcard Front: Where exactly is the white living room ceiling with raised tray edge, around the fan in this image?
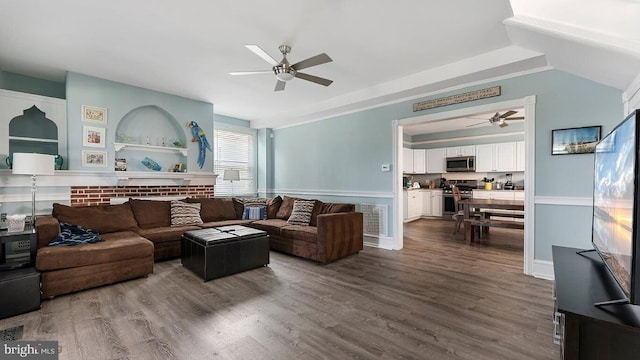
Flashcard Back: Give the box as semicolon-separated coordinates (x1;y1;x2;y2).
0;0;640;128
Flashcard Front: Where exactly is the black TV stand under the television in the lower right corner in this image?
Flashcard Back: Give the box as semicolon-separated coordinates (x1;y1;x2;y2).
553;246;640;360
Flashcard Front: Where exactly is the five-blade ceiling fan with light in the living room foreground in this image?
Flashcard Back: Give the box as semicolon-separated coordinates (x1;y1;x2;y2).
229;45;333;91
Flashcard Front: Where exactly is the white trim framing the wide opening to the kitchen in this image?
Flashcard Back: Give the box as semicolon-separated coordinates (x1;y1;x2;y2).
392;95;536;275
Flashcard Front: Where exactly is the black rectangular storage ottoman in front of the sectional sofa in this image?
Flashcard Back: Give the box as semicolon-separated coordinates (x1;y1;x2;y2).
181;225;269;281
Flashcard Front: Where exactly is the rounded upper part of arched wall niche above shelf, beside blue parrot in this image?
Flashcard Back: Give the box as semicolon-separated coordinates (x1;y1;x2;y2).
116;105;186;147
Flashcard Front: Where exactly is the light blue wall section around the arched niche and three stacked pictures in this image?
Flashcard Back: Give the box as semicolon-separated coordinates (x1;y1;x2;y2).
66;73;213;172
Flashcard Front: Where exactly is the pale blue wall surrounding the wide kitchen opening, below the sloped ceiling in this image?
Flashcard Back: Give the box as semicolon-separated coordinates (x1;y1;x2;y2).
273;70;624;260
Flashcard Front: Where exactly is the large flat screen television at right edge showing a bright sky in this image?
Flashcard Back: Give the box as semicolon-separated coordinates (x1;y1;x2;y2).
591;110;640;305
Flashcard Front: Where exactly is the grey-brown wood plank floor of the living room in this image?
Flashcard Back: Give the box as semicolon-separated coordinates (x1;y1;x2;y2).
0;220;559;360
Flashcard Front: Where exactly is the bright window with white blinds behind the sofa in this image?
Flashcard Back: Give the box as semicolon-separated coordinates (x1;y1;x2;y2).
213;124;257;196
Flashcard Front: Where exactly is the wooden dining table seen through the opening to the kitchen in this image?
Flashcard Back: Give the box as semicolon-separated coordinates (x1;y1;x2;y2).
459;198;524;244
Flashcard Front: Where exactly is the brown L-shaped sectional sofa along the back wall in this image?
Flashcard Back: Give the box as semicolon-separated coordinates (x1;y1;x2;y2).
36;196;363;298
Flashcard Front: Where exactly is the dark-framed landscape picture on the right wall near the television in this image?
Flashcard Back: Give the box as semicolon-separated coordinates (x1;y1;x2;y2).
551;126;602;155
